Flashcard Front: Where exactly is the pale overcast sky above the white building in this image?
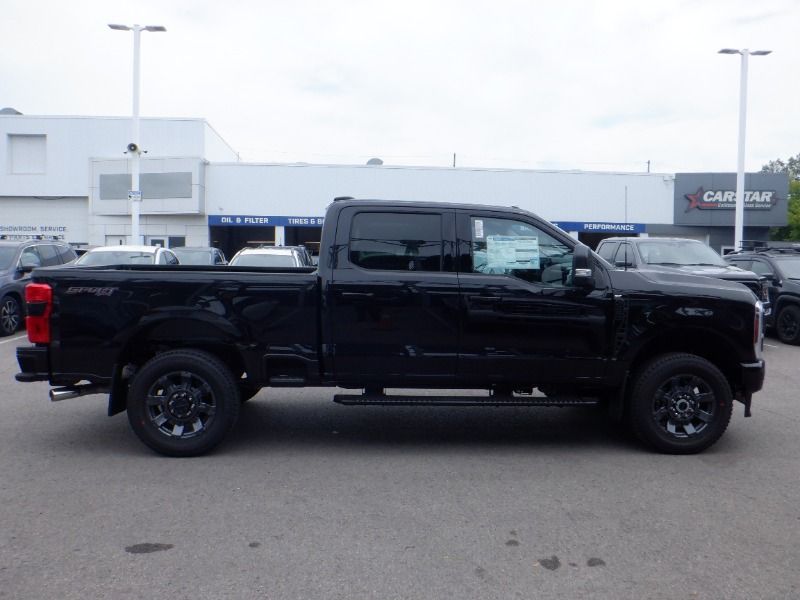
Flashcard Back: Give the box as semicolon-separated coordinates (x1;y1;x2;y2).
0;0;800;173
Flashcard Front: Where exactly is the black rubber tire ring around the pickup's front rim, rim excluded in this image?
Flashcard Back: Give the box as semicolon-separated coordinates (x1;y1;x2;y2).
629;354;733;454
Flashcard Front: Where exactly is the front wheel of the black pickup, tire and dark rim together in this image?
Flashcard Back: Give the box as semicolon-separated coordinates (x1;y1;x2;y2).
629;353;733;454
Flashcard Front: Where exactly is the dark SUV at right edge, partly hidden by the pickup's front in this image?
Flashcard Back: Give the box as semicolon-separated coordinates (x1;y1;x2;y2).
725;244;800;345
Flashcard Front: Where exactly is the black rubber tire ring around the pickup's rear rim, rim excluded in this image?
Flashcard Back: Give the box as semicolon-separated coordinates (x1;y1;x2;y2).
128;350;240;456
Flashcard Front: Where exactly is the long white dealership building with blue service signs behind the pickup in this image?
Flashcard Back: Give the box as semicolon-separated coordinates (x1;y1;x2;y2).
0;109;788;254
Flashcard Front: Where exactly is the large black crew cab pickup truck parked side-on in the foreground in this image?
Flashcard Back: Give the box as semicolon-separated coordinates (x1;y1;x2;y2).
16;199;764;456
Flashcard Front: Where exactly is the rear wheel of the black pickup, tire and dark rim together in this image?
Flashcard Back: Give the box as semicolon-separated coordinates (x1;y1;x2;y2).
128;350;241;456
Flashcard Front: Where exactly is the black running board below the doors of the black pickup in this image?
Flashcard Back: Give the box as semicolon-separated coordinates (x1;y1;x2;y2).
333;394;598;406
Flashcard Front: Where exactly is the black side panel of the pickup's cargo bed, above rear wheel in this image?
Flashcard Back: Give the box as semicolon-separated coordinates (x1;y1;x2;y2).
37;265;319;383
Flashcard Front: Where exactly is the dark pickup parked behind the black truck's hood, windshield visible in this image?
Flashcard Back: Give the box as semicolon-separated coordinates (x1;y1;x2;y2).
597;237;771;315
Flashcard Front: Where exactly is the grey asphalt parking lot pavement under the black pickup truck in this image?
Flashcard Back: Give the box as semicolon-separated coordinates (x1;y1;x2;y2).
0;337;800;600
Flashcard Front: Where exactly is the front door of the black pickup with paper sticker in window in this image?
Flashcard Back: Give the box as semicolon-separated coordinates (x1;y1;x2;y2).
450;210;612;385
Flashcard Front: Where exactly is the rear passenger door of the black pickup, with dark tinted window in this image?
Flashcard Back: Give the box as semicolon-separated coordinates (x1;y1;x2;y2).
325;205;459;387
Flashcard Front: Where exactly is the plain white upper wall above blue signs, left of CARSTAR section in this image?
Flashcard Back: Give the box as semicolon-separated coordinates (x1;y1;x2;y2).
206;164;674;224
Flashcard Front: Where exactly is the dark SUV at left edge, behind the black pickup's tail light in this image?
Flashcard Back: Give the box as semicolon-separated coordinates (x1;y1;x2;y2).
0;238;76;335
